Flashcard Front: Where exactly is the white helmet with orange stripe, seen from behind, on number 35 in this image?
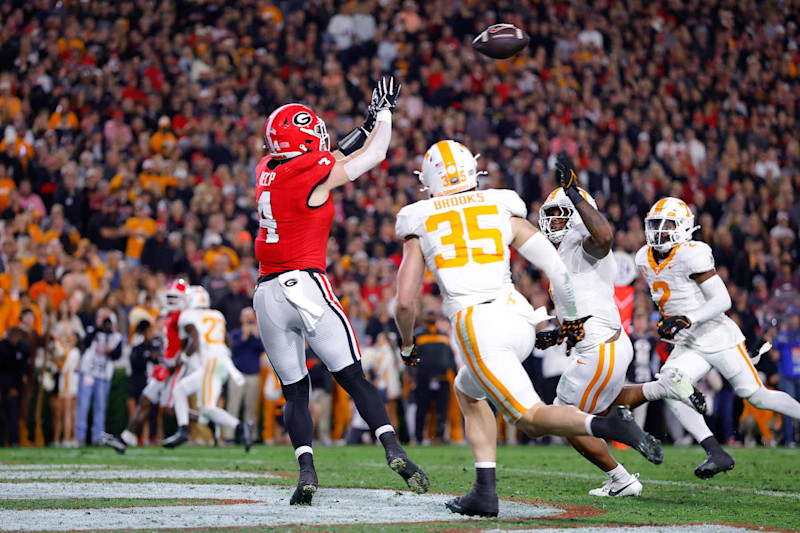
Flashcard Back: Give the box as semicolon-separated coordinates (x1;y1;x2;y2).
416;140;481;196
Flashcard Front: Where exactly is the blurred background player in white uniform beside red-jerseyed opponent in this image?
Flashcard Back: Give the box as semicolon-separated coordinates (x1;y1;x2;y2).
163;285;253;452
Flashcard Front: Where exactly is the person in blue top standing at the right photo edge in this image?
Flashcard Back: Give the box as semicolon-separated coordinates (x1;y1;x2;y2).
773;306;800;448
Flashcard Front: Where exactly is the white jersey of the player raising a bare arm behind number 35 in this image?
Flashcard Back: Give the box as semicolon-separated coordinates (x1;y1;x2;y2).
556;224;622;351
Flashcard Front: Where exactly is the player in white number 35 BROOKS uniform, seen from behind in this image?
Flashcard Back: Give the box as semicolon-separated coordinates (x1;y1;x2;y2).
396;141;663;516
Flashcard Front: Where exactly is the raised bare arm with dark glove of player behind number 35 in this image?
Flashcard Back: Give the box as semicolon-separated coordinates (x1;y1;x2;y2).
556;152;614;259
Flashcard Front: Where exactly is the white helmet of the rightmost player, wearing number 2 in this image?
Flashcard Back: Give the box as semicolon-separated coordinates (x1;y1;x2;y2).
644;196;700;252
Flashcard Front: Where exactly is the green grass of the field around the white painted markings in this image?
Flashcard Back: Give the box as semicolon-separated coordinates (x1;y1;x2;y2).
0;446;800;531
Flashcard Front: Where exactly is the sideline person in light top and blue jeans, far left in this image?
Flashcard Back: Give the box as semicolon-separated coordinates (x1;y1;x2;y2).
75;307;123;445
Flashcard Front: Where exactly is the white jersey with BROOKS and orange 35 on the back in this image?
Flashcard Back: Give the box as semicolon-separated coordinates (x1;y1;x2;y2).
395;189;527;317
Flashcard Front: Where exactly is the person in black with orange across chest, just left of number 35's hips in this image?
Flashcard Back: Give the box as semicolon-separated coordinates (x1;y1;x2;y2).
414;309;456;444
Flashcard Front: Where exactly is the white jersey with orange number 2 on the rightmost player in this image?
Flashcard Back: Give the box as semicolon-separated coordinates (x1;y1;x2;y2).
636;241;744;353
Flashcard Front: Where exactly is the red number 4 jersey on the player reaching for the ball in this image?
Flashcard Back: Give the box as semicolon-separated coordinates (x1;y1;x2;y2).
255;152;336;276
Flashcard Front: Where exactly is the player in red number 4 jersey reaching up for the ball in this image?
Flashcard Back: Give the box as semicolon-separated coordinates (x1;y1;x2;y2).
253;78;430;505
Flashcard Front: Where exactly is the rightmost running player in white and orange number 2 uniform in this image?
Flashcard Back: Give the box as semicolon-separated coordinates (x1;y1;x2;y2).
636;198;800;479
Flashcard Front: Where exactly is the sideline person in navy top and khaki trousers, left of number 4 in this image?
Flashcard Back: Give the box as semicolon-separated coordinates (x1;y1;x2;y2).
226;307;264;439
